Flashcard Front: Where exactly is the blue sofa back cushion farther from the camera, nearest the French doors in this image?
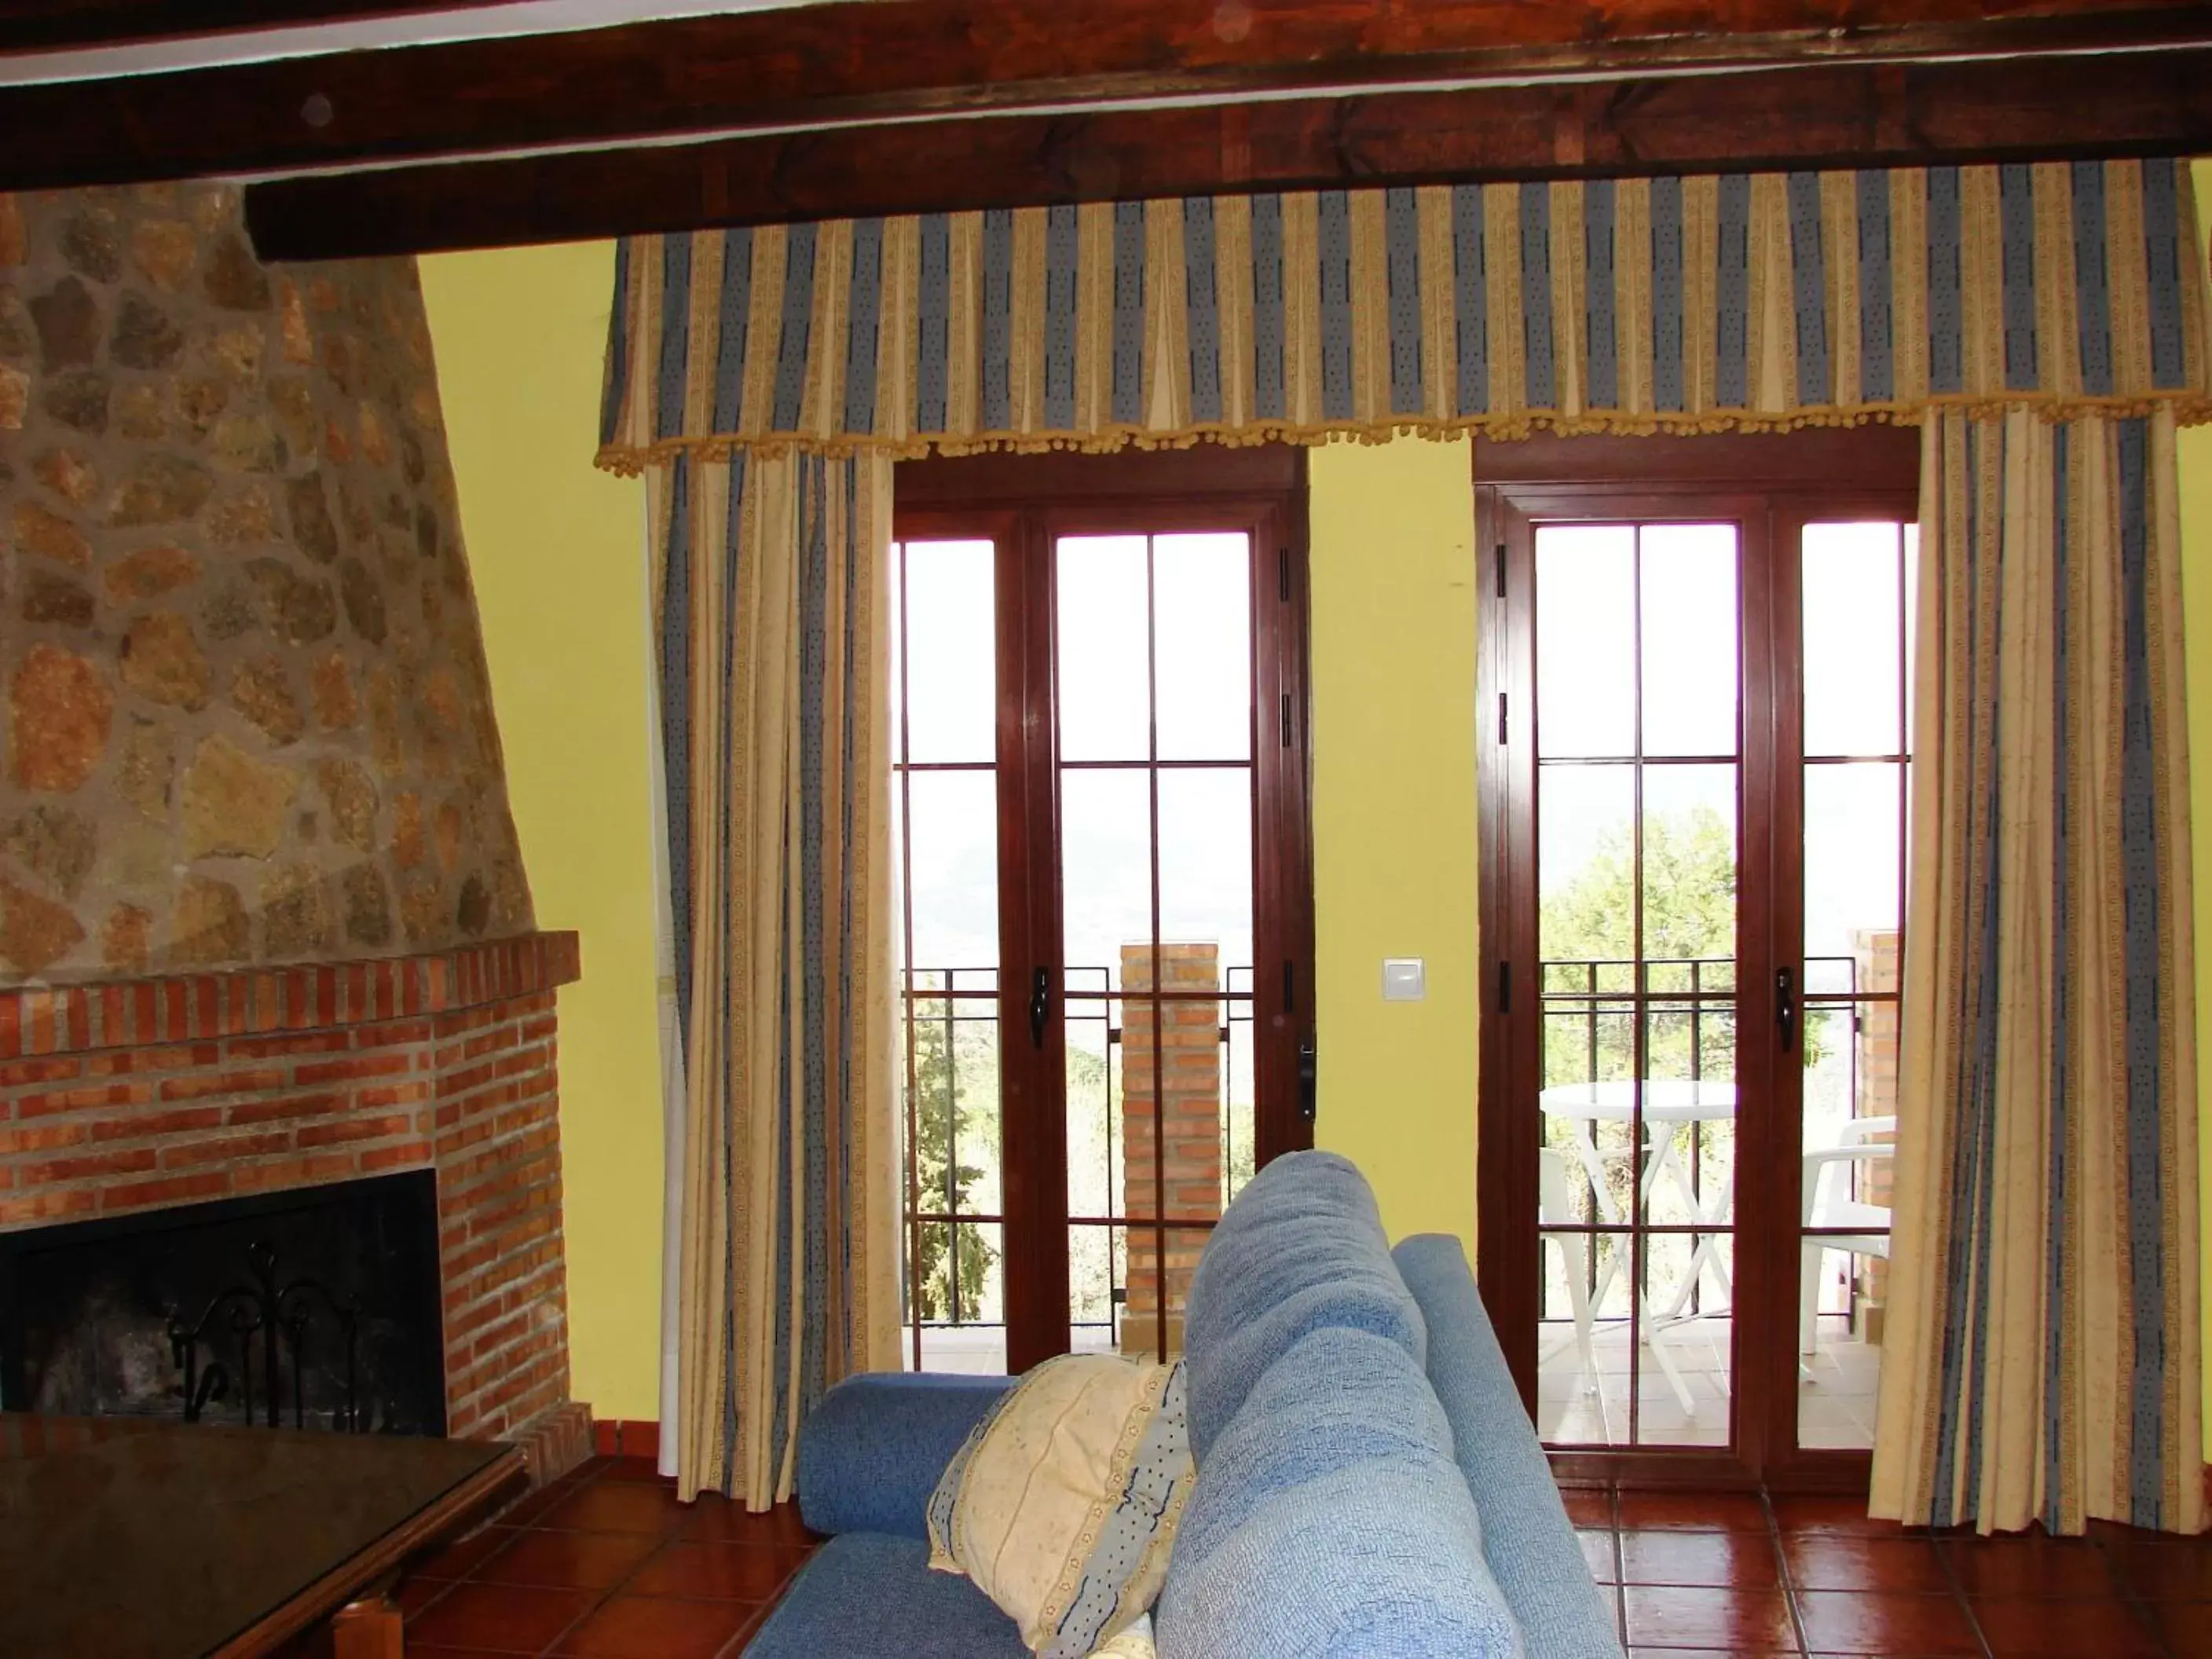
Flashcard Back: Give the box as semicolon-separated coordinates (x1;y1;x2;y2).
1184;1152;1426;1469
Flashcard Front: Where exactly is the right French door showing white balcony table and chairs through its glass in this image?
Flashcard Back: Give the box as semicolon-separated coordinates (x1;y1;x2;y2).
1478;431;1917;1486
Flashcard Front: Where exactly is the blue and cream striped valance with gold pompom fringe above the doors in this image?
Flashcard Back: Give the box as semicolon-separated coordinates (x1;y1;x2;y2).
599;162;2212;471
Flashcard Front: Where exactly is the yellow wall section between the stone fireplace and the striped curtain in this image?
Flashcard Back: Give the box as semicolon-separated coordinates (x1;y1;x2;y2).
423;244;661;1418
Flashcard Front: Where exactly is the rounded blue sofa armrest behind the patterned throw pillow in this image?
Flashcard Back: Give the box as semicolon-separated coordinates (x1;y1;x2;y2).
799;1372;1013;1537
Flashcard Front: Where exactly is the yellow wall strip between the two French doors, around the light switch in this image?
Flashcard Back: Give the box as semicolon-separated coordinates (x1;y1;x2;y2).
1309;440;1480;1258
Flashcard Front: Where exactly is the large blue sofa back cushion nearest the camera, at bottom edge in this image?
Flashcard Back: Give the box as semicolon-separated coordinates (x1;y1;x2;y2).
1155;1328;1522;1659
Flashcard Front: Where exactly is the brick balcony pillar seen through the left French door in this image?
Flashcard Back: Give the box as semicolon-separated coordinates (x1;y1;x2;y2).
1122;944;1221;1353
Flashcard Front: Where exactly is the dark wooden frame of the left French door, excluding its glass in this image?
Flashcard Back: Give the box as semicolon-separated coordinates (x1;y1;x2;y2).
894;447;1314;1372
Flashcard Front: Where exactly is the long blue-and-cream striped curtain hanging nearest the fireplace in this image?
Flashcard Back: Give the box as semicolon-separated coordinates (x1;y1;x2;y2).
648;445;898;1509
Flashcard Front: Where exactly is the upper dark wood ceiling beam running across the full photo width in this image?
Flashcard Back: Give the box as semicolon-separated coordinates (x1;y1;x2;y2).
0;0;2212;188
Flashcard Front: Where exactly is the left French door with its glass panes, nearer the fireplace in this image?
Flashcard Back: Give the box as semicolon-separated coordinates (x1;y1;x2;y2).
892;451;1314;1372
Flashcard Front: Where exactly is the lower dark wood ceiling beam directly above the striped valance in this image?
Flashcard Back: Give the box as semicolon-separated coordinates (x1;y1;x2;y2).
246;49;2212;258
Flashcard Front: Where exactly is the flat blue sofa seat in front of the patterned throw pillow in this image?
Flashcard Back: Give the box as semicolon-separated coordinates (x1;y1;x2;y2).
745;1533;1031;1659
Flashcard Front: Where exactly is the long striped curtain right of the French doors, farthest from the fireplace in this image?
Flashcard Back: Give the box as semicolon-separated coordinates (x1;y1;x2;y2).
1873;414;2206;1533
